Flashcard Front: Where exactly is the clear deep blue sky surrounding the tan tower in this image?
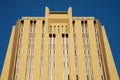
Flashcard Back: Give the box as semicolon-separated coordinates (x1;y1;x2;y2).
0;0;120;76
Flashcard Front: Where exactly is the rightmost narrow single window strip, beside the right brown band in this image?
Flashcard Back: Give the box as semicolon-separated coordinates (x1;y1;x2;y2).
94;21;105;80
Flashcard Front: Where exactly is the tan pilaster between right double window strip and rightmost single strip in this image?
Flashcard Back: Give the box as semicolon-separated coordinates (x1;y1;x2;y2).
87;20;101;80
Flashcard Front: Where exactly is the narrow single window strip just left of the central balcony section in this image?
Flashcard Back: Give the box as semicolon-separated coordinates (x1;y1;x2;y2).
40;21;45;80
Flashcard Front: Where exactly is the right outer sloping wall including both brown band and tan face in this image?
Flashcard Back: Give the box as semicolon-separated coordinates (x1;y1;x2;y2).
99;26;119;80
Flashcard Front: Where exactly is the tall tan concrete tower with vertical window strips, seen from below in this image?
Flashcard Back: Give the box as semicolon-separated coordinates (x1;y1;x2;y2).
1;7;119;80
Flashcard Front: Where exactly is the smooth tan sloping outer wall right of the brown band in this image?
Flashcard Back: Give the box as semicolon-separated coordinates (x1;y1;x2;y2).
102;26;119;80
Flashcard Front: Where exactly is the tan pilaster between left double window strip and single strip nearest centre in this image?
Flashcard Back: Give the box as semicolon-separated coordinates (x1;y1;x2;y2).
33;20;42;80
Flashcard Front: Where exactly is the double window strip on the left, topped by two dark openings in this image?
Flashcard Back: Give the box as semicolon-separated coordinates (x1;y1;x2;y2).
26;21;36;80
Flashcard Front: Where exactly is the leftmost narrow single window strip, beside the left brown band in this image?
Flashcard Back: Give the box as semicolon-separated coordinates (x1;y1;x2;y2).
14;21;24;80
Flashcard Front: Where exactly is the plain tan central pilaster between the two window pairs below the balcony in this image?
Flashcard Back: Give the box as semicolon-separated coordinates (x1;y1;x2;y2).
56;34;63;80
